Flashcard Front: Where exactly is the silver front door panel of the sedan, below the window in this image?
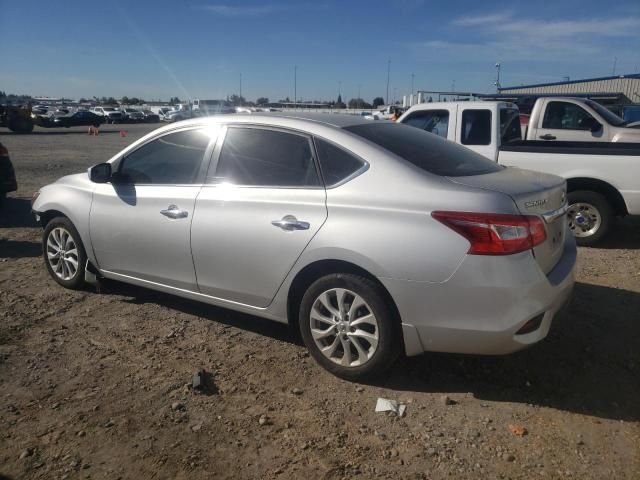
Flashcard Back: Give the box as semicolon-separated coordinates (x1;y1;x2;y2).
90;183;201;290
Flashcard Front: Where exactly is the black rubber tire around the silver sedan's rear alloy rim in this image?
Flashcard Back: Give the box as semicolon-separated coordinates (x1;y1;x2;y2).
299;273;402;381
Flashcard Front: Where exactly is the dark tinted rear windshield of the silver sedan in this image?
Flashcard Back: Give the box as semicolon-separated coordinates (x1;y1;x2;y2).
345;122;503;177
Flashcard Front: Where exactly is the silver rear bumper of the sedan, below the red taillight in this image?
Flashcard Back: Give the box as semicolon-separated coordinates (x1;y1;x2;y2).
380;235;576;355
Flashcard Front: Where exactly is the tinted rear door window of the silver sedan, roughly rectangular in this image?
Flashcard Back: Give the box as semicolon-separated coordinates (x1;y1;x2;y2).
212;127;321;187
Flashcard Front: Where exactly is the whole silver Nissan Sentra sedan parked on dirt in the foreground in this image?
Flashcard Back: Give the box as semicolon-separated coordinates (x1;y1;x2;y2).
33;114;576;379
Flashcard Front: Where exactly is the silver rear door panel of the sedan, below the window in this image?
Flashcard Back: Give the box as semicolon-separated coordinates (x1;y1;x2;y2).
191;185;327;307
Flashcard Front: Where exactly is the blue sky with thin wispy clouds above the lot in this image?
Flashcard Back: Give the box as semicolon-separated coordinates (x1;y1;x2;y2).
0;0;640;101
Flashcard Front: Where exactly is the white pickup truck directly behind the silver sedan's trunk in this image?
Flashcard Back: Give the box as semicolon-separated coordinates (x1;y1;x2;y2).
398;102;640;245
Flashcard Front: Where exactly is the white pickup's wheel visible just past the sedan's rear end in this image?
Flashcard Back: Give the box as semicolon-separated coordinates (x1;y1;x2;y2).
567;190;613;247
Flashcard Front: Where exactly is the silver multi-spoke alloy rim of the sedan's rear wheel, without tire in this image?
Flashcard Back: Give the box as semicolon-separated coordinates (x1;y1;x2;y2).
309;288;380;367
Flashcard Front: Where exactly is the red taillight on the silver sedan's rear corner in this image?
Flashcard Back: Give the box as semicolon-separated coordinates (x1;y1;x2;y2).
431;212;547;255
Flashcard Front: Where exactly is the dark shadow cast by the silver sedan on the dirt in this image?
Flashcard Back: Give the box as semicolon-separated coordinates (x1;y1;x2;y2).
97;281;640;421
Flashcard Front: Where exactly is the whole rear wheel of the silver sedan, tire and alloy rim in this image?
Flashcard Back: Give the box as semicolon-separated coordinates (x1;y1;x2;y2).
299;273;400;380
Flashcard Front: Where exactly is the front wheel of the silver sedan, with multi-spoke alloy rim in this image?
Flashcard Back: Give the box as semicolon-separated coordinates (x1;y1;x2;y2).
42;217;87;289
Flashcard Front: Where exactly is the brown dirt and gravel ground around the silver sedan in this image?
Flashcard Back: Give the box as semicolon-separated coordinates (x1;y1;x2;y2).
0;125;640;479
